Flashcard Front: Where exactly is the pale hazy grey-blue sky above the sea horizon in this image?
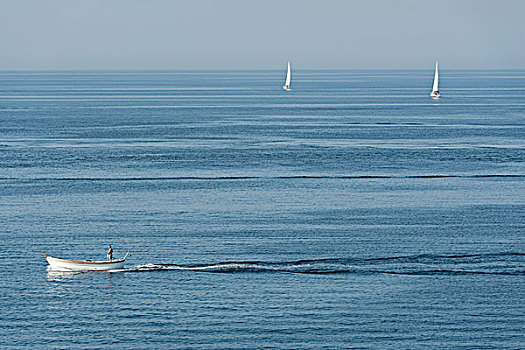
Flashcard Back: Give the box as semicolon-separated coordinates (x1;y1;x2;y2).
0;0;525;70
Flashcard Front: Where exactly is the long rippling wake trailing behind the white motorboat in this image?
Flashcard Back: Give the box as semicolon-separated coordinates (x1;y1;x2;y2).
123;253;525;275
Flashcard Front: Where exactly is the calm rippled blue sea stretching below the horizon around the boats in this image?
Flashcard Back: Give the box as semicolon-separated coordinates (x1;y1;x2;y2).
0;69;525;349
